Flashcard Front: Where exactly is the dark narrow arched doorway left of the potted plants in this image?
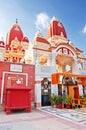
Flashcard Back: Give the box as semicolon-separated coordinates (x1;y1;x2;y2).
41;78;51;106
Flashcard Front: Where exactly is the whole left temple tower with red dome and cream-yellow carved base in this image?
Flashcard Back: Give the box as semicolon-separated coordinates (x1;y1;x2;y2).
4;21;29;63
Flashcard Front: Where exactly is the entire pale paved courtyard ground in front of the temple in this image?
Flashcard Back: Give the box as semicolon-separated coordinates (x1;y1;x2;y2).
0;107;86;130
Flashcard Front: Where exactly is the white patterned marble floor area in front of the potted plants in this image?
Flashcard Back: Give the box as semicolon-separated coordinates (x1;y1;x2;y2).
41;106;86;126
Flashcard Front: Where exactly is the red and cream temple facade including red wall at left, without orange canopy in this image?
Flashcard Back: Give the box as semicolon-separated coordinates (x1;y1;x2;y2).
0;17;86;107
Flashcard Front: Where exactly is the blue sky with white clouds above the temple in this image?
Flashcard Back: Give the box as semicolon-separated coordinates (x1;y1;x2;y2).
0;0;86;56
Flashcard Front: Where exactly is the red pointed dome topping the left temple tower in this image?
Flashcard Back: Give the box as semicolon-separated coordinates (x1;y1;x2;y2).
6;22;23;49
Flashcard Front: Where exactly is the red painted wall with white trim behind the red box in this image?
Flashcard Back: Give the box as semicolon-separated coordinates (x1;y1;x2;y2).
0;61;35;102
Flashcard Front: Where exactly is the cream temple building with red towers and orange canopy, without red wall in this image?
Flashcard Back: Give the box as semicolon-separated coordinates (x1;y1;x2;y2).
0;17;86;107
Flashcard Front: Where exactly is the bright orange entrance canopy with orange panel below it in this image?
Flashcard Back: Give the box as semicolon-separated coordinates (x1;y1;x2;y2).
52;73;86;98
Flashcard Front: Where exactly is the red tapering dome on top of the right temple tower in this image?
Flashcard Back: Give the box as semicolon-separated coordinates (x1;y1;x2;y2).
46;17;67;39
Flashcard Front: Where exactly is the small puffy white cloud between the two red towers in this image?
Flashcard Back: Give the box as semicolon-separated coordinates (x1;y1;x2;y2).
35;13;50;29
